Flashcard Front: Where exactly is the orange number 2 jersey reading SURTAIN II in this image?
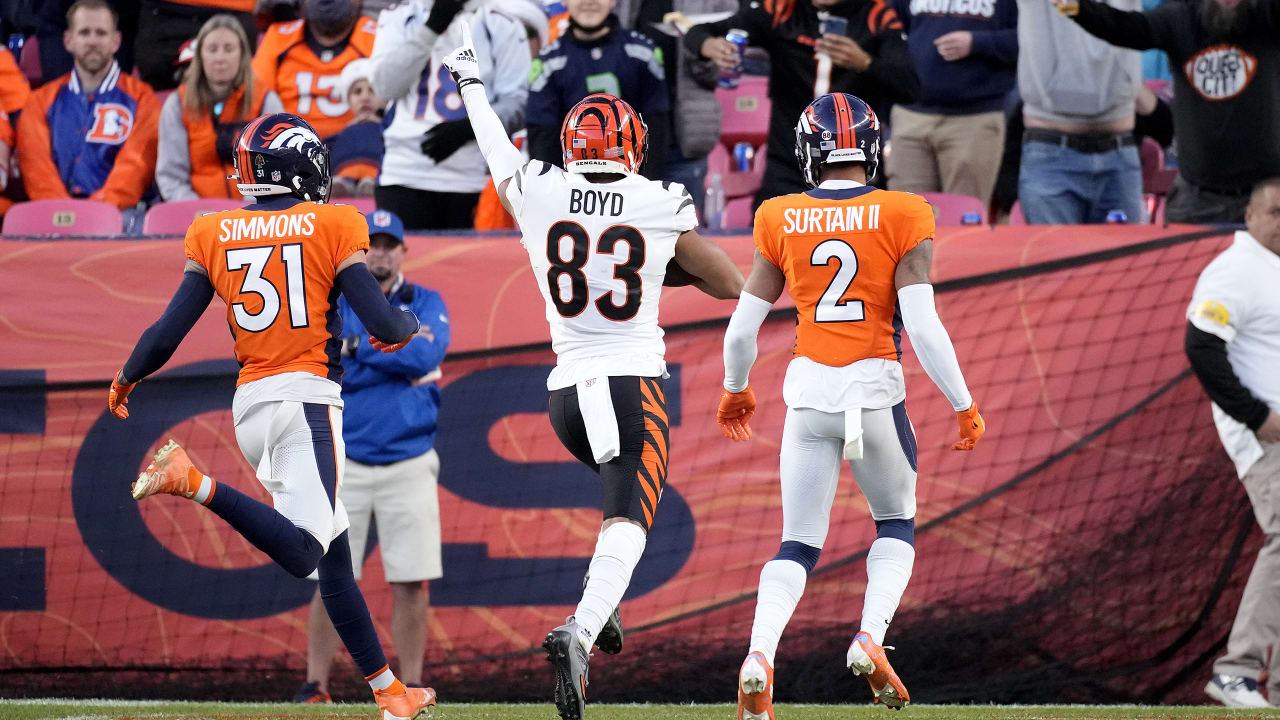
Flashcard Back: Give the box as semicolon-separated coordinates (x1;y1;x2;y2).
755;186;933;368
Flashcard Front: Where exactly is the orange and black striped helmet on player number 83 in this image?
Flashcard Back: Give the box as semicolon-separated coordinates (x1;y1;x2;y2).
561;92;649;174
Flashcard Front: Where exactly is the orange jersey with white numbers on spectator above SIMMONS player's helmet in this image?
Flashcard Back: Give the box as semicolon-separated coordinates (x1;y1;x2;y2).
253;17;378;141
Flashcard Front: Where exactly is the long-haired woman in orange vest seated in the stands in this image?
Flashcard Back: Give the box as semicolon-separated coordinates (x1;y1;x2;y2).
156;14;284;201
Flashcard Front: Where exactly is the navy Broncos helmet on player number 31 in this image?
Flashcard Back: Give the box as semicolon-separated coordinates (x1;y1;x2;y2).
234;113;333;202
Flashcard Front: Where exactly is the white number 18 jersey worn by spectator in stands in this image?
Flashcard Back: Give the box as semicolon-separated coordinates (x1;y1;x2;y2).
370;0;531;192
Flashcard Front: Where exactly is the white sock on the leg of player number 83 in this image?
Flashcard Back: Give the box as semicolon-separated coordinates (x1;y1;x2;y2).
573;523;645;652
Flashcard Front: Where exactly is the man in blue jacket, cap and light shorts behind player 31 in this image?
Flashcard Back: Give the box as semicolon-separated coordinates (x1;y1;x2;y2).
294;210;449;702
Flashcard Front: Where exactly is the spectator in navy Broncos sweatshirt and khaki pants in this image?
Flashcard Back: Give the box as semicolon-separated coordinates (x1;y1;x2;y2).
886;0;1018;204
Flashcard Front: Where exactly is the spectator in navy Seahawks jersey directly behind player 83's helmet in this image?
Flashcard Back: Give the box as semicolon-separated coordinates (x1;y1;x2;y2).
525;0;671;179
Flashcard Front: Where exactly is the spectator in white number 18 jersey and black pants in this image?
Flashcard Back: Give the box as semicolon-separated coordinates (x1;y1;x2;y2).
371;0;530;229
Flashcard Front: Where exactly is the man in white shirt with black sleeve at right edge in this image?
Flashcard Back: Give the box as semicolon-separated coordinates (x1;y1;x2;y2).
1187;177;1280;707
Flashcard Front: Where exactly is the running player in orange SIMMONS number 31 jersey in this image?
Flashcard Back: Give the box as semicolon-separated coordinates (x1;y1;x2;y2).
106;113;435;720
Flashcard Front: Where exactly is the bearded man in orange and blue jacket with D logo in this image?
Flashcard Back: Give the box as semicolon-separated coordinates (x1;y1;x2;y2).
18;0;160;209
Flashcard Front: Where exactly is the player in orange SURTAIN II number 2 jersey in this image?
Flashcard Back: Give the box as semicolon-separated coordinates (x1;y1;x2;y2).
717;94;984;720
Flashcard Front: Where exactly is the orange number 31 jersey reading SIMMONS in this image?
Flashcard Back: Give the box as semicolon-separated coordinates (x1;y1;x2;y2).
186;202;369;386
